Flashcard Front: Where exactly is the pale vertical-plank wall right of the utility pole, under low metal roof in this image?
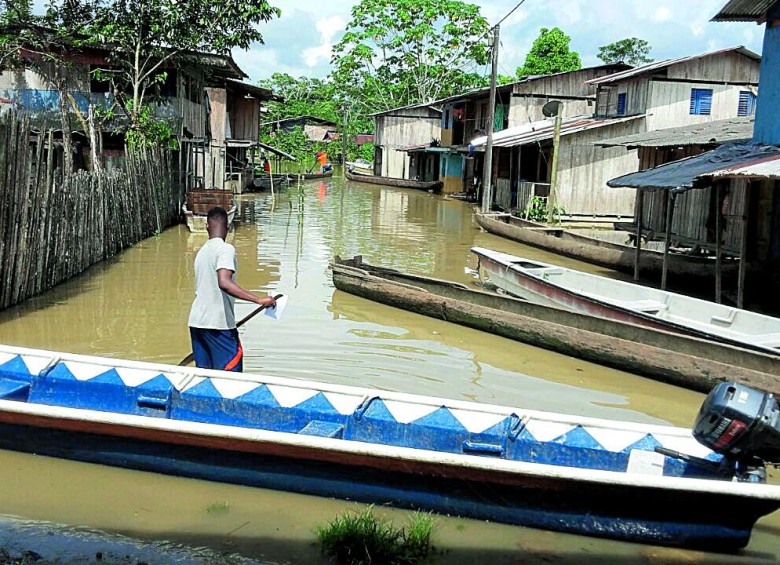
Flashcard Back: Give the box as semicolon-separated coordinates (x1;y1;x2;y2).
556;119;644;217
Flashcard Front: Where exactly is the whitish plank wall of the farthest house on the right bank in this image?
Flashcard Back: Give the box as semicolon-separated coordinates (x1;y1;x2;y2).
374;108;441;178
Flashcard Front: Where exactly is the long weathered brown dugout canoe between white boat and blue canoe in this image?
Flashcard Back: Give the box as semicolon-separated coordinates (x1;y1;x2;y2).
331;258;780;395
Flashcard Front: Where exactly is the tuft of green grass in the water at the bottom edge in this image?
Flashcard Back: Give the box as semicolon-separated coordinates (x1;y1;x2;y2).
316;506;434;565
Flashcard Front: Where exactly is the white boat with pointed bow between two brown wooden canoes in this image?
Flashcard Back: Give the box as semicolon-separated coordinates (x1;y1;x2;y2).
471;247;780;355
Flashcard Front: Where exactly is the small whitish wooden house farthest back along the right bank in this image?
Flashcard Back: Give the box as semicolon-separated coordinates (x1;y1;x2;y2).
370;104;441;180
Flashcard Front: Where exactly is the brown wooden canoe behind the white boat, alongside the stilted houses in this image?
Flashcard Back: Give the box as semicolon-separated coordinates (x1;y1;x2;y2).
476;213;737;278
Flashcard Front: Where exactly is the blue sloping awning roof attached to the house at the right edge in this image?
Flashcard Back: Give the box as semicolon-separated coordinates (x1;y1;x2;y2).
607;143;780;190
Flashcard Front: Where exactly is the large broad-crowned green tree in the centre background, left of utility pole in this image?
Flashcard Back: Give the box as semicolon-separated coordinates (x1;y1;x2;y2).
332;0;489;113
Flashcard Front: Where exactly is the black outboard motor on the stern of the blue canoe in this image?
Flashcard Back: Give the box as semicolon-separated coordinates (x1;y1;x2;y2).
693;383;780;480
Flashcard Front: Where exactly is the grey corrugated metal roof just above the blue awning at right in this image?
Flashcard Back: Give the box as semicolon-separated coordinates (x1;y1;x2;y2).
594;116;755;149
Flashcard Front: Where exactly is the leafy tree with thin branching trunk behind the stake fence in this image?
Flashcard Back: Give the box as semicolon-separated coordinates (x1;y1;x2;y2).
48;0;280;143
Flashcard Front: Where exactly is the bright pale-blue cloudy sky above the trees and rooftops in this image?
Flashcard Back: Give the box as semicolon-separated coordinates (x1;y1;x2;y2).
233;0;763;83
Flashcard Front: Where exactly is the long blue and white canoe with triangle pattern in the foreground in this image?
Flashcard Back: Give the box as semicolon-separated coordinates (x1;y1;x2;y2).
0;346;780;550
